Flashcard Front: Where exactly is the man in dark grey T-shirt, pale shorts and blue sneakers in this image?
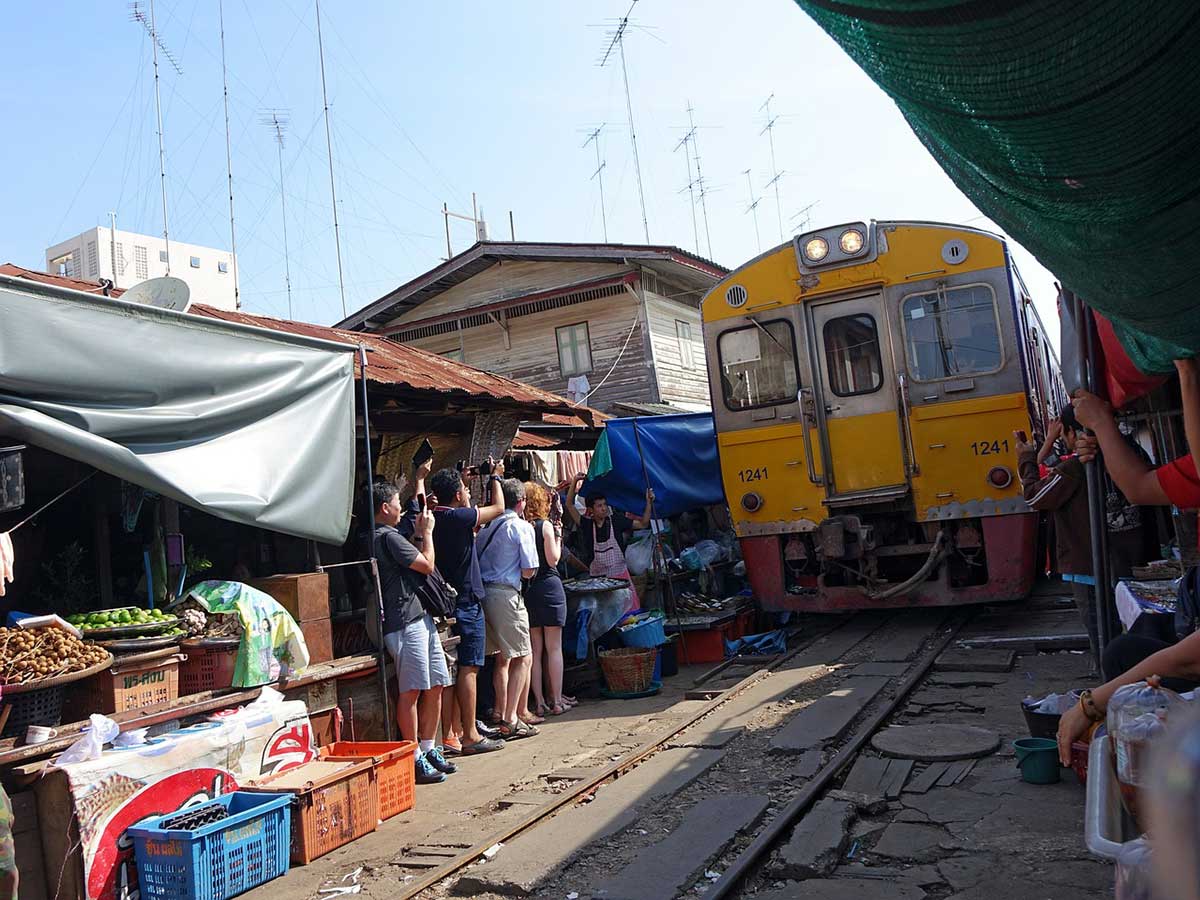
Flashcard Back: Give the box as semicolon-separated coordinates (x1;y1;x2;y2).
372;481;456;785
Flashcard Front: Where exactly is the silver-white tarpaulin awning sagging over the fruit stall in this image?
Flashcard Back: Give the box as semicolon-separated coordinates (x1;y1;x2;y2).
0;276;355;544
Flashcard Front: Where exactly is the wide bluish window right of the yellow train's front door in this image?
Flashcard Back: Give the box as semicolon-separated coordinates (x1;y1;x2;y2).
901;284;1004;382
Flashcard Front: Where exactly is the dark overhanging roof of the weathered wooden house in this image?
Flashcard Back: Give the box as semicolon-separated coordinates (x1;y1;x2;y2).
337;241;728;329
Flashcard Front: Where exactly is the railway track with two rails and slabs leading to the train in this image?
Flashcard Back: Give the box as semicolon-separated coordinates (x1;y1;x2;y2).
392;610;968;900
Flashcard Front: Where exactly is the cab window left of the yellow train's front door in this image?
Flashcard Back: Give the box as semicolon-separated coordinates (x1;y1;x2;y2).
716;319;799;410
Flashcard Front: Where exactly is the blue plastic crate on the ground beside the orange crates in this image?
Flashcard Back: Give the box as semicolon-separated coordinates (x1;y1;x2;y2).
127;791;293;900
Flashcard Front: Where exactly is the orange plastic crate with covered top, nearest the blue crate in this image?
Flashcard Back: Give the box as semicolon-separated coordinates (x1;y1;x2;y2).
238;760;379;865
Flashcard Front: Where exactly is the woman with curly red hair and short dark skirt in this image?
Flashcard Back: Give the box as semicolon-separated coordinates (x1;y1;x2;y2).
524;481;569;715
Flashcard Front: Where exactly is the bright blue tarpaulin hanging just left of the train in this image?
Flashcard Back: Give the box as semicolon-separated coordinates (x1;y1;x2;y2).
582;413;725;517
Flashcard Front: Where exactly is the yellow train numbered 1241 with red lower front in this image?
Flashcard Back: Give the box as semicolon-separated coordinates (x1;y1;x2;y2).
701;221;1068;612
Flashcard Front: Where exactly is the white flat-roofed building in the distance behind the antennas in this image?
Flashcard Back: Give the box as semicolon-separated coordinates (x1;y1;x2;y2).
46;227;236;310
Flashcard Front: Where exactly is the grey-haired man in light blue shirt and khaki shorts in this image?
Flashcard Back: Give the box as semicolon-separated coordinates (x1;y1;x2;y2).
475;478;538;739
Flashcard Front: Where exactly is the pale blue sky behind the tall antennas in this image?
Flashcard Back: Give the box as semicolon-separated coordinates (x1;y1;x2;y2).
0;0;1056;340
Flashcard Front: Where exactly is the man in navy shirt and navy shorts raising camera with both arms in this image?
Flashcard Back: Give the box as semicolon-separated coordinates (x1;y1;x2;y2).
416;462;504;756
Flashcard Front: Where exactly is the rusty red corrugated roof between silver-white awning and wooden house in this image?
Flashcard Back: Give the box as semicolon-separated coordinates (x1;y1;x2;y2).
188;304;607;427
